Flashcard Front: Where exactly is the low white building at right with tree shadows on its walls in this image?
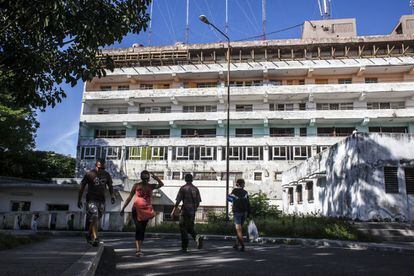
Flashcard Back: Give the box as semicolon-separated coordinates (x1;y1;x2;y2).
283;133;414;221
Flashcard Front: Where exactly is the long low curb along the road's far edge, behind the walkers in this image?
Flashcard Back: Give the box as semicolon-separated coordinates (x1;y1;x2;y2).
0;230;414;254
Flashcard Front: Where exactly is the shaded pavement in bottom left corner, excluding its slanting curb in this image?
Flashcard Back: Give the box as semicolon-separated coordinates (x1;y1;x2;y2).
0;237;91;276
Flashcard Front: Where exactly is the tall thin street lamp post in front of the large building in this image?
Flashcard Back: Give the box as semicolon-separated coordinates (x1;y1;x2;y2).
199;15;230;221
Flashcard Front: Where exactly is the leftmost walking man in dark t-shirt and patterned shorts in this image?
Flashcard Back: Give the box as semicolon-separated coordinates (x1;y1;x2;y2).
78;159;115;246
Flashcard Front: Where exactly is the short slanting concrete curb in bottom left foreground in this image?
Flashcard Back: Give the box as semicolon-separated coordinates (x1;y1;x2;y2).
62;243;104;276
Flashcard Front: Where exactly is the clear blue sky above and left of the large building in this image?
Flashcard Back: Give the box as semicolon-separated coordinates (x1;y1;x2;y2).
36;0;412;156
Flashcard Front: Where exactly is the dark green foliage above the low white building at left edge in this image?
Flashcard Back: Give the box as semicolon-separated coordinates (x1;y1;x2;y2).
0;151;76;180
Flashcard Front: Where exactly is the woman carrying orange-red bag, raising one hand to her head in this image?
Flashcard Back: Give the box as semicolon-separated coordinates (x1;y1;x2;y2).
121;170;164;257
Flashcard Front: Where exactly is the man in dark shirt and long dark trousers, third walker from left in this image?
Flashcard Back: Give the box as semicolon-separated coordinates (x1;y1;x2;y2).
171;174;203;252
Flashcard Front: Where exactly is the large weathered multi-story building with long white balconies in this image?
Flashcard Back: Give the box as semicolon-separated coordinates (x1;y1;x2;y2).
77;16;414;216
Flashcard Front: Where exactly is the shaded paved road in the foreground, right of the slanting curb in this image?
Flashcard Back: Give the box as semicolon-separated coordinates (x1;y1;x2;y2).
96;235;414;276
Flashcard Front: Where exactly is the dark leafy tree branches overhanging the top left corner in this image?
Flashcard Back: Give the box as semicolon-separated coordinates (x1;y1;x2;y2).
0;0;150;109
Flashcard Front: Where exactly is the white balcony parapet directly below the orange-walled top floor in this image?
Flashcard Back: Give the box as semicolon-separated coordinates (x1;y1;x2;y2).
84;82;414;104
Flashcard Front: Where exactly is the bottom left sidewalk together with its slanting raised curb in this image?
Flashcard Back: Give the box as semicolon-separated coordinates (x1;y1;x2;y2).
0;237;103;276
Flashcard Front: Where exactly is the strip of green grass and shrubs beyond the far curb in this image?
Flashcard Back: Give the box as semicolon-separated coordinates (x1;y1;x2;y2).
124;216;379;242
